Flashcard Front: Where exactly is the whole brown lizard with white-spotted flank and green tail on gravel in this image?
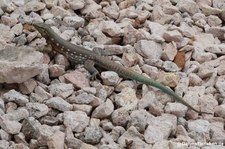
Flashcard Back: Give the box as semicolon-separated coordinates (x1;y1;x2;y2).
32;22;209;114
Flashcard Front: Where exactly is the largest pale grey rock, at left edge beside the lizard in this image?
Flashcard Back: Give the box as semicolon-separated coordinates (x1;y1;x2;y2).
0;47;43;83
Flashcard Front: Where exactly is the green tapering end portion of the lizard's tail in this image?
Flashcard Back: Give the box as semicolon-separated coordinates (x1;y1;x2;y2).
132;75;209;114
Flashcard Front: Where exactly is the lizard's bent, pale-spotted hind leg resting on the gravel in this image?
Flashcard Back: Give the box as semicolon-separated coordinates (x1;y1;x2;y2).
84;60;100;80
